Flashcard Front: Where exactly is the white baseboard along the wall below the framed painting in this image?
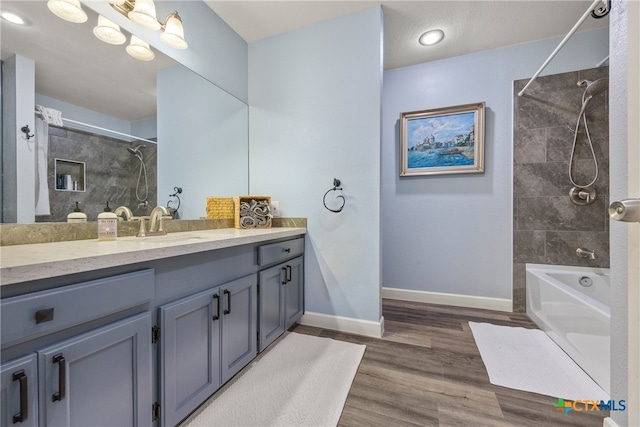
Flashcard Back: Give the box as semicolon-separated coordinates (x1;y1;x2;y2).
380;288;513;312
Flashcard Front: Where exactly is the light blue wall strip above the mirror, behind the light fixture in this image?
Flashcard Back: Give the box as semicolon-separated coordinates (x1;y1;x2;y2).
83;0;248;102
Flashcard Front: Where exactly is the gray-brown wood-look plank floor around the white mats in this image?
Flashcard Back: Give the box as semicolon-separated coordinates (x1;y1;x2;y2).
293;300;609;427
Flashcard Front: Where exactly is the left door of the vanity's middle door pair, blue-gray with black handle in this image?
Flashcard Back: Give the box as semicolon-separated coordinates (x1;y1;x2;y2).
160;288;222;426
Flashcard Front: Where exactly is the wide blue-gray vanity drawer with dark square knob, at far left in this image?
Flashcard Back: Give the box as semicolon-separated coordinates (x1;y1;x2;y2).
0;269;154;346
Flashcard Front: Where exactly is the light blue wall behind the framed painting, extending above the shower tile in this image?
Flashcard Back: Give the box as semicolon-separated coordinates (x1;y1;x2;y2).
381;29;609;300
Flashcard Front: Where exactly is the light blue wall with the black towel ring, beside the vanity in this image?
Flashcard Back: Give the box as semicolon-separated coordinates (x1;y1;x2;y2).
249;7;382;322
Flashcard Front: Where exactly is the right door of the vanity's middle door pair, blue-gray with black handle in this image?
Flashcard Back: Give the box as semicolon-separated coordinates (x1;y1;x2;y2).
220;274;258;383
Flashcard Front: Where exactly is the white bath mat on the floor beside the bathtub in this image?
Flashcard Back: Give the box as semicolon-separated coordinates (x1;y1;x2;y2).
469;322;609;401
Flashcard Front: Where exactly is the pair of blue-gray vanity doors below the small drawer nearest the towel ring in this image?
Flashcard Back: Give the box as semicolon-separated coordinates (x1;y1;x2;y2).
258;256;304;351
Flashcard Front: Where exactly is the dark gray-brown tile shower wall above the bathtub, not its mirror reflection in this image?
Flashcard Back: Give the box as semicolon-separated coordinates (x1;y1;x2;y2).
513;67;609;312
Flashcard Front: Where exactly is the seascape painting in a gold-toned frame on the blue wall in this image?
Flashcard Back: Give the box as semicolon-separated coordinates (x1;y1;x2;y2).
400;103;484;176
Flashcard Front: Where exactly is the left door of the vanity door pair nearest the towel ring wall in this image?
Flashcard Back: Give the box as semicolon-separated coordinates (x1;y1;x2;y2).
258;264;286;351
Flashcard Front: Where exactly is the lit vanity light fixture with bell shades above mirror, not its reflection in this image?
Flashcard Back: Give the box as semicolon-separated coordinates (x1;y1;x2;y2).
108;0;189;49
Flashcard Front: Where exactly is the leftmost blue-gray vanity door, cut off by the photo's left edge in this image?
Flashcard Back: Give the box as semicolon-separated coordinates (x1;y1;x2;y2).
0;353;38;427
